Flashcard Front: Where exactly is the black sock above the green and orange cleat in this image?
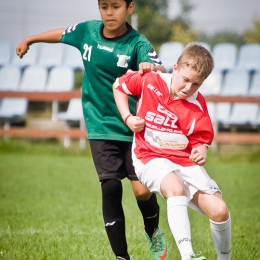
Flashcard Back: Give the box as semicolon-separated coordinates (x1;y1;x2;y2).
137;193;160;237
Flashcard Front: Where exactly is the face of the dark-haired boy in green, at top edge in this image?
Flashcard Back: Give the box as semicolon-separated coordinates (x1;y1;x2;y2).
99;0;134;38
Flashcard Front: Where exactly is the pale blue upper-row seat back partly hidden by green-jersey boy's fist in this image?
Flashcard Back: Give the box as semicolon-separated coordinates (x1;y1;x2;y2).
11;44;39;69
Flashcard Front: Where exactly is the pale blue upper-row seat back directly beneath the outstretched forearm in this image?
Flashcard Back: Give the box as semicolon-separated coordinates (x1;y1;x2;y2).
37;43;64;69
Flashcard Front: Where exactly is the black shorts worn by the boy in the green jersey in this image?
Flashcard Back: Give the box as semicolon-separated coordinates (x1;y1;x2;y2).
89;140;138;181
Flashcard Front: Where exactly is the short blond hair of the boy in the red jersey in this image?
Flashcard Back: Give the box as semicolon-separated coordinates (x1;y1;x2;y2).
177;43;214;79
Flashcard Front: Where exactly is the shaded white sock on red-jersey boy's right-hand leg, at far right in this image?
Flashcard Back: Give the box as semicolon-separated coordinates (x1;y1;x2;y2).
209;217;231;260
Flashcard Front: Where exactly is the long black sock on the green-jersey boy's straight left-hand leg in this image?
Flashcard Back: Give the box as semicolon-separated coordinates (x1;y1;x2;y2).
101;179;130;259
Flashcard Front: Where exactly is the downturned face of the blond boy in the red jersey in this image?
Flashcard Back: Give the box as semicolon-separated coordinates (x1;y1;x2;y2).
171;64;204;99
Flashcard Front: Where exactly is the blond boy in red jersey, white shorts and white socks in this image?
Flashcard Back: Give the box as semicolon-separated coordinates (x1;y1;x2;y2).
113;44;231;260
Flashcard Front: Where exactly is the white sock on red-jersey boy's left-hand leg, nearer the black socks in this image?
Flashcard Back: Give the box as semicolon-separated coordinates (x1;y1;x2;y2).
167;196;193;259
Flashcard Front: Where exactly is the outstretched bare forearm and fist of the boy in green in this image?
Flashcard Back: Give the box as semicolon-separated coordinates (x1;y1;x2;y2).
16;28;65;58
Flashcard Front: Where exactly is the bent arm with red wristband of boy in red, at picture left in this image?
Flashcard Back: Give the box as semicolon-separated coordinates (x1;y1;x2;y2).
113;83;144;133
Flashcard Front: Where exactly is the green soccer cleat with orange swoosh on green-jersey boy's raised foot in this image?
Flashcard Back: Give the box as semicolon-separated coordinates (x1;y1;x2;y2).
145;227;169;260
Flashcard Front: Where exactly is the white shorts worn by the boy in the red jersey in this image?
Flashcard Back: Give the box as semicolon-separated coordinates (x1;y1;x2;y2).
133;158;221;214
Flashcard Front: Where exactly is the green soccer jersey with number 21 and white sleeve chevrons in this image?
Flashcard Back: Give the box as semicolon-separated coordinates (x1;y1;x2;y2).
61;21;161;141
